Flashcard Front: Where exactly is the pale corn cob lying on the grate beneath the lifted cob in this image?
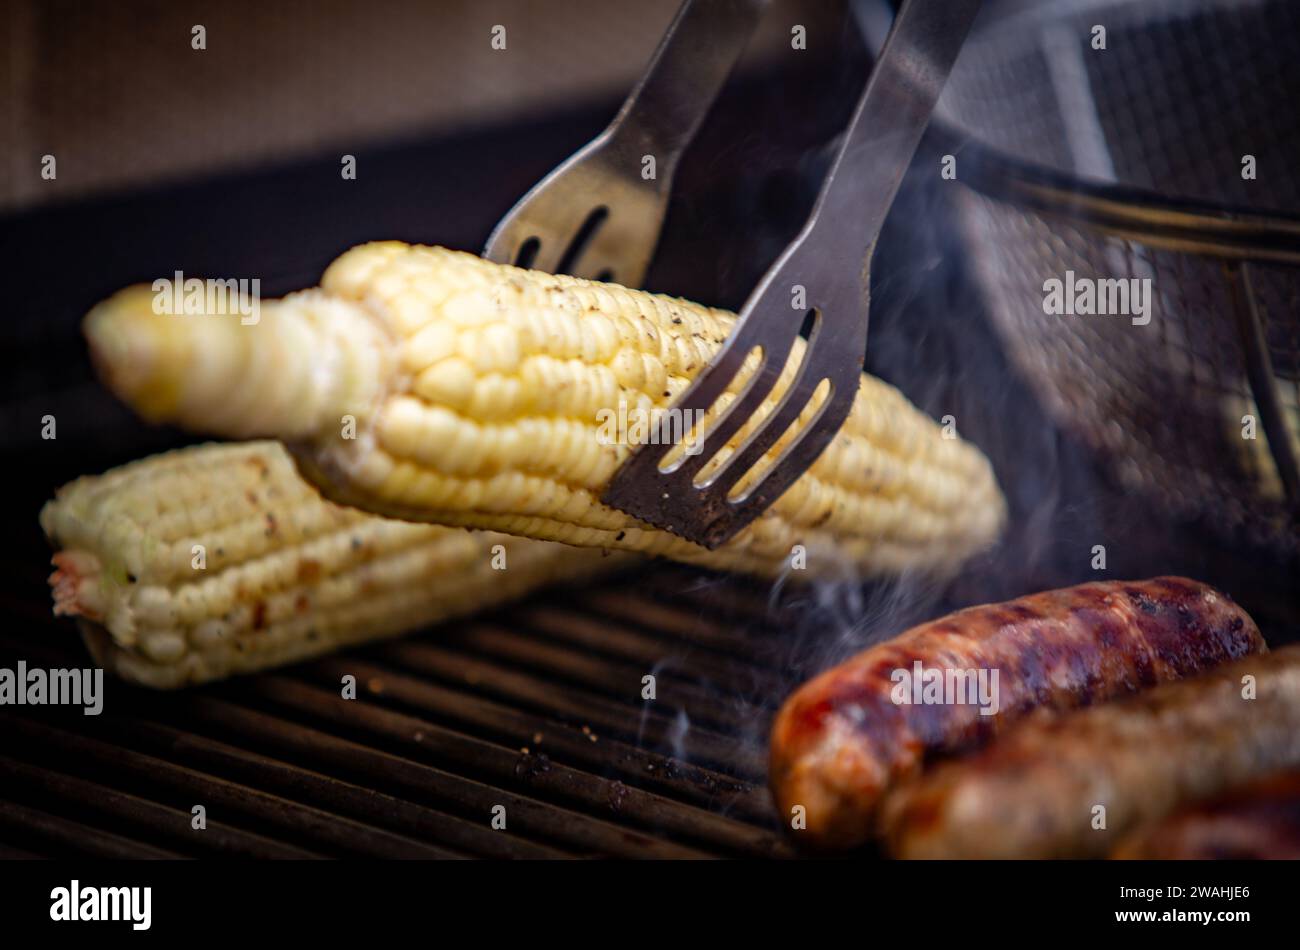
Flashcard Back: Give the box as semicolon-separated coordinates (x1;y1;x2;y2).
40;442;624;689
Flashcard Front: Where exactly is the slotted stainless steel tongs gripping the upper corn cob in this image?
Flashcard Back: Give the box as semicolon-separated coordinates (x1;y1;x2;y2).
484;0;980;548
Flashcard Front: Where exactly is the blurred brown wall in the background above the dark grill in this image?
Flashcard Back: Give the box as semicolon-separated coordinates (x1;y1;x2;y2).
0;0;836;211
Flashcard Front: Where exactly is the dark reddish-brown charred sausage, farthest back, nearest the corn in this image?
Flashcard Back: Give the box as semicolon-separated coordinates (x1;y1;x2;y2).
771;577;1265;847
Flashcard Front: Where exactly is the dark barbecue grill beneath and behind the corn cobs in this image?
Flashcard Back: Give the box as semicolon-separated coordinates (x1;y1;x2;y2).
0;0;1300;858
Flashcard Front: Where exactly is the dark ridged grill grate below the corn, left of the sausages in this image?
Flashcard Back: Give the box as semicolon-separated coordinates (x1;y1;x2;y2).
0;551;792;858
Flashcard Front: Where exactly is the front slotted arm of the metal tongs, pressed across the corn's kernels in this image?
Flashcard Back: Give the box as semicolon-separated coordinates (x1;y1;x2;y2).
603;0;980;547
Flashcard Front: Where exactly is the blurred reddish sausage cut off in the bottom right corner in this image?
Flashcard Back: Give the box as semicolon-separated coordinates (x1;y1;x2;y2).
1110;772;1300;860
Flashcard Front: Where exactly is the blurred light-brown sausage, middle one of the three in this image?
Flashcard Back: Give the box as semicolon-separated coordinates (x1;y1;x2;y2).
881;647;1300;858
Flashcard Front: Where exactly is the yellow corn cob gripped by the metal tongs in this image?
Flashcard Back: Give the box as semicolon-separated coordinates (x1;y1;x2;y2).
86;243;1005;574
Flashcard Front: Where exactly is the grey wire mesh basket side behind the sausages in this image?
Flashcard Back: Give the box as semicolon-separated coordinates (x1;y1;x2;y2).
943;0;1300;556
